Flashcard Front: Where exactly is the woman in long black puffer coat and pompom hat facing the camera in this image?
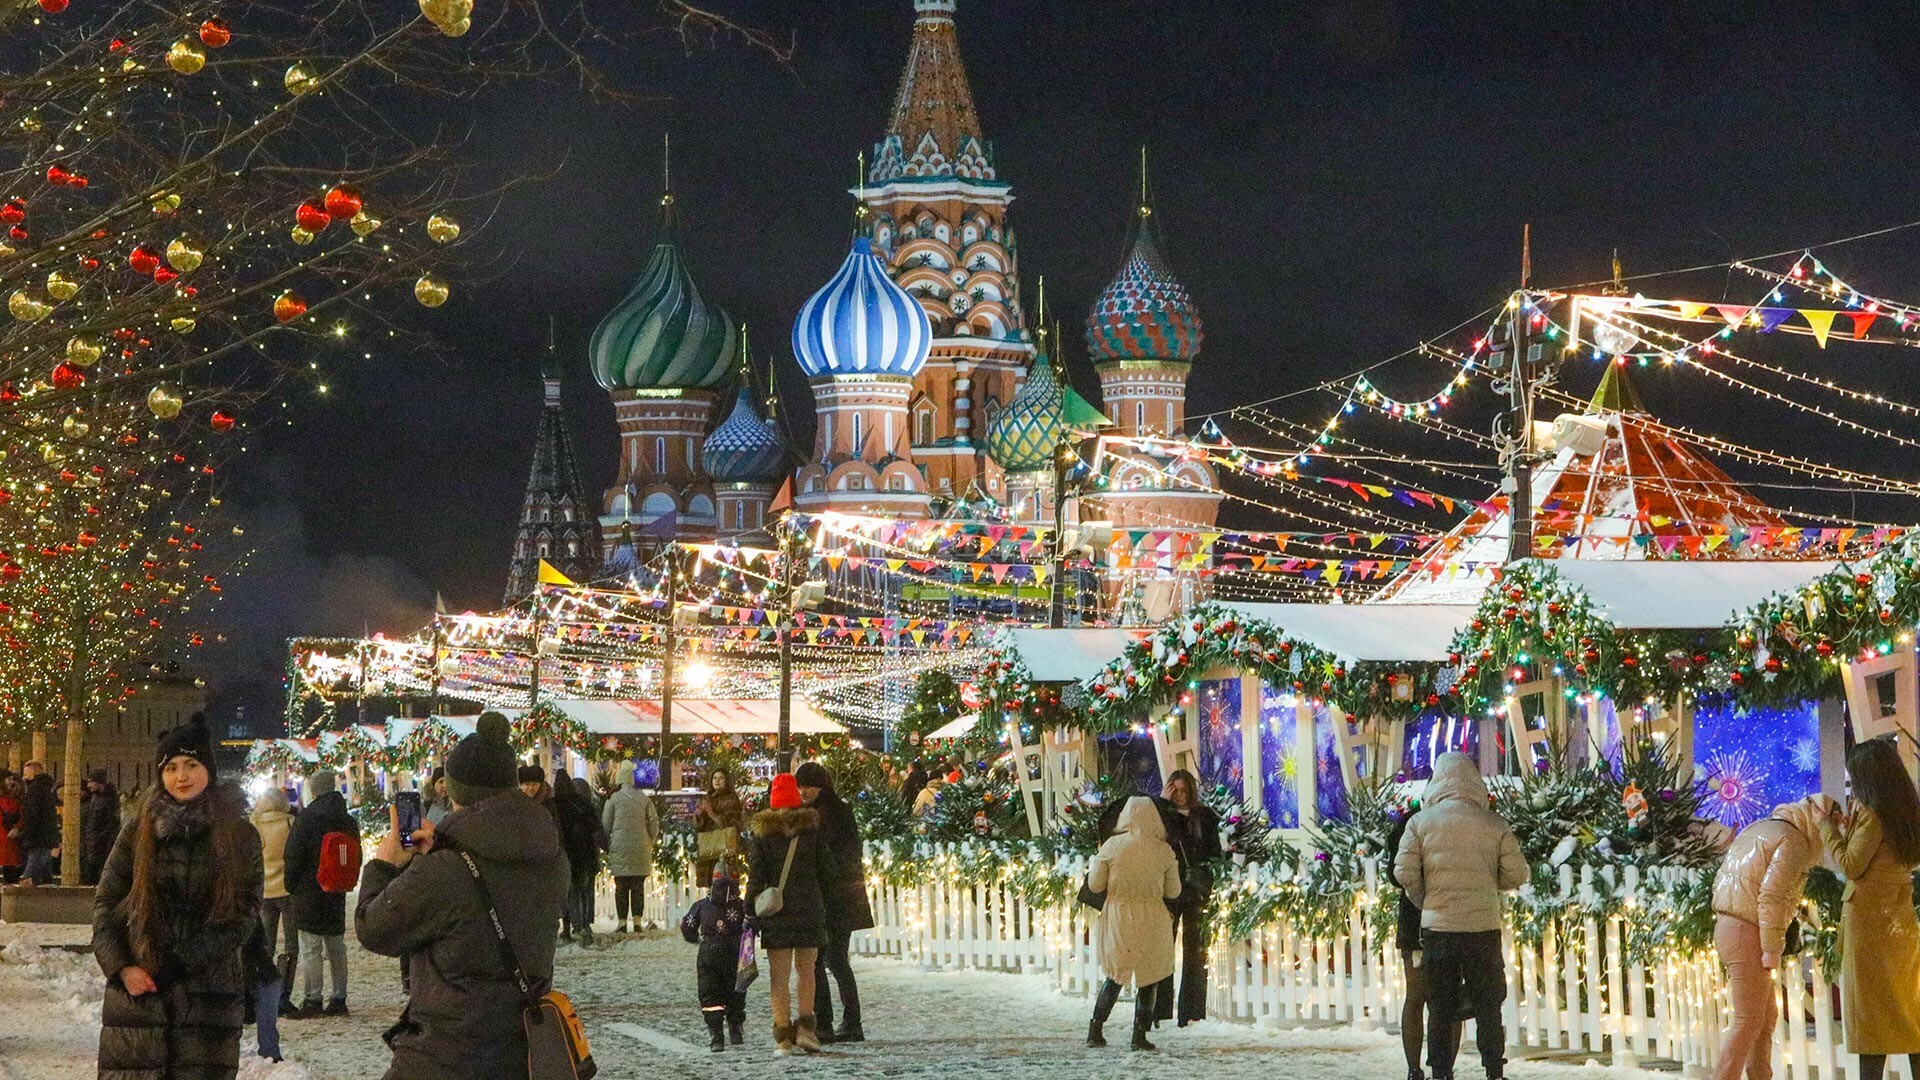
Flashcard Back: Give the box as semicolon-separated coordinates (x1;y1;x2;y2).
94;715;261;1080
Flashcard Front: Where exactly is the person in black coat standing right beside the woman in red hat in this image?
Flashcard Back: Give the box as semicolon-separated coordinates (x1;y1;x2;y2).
793;761;874;1042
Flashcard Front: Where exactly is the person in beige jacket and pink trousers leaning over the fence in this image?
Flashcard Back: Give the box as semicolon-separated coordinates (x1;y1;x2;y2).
1713;796;1834;1080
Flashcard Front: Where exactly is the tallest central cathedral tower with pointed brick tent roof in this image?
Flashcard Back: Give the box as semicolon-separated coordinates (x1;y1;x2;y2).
852;0;1033;498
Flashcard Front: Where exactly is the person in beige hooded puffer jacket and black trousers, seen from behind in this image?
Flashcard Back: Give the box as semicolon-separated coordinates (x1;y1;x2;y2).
1394;753;1530;1080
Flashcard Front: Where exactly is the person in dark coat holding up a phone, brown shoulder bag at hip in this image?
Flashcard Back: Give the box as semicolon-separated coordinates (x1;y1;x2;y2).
353;715;570;1080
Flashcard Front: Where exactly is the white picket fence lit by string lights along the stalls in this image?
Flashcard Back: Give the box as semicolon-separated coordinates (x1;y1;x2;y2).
629;846;1873;1080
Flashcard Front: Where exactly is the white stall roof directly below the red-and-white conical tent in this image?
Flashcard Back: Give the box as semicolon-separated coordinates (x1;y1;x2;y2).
1540;559;1841;630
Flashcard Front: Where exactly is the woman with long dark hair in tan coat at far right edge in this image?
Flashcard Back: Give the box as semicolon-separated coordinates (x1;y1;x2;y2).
1820;738;1920;1080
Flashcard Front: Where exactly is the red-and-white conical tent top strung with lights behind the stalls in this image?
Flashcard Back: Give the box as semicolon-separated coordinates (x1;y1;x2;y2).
1380;361;1788;603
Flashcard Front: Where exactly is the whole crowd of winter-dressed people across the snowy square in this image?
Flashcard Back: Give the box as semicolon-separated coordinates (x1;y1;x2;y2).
71;715;1920;1080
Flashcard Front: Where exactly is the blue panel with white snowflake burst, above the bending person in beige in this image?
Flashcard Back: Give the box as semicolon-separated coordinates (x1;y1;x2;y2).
1693;701;1820;830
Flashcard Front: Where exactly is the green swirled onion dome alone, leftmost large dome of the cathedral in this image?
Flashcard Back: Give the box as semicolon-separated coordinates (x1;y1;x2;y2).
588;242;737;390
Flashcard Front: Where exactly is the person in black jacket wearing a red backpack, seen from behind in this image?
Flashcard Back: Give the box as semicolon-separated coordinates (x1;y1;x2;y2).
286;769;359;1020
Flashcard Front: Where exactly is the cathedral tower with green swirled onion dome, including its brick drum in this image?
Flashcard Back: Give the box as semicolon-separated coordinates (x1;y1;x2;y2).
589;134;737;557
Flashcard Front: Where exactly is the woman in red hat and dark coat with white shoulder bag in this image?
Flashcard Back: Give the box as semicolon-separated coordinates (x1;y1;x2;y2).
747;773;828;1055
